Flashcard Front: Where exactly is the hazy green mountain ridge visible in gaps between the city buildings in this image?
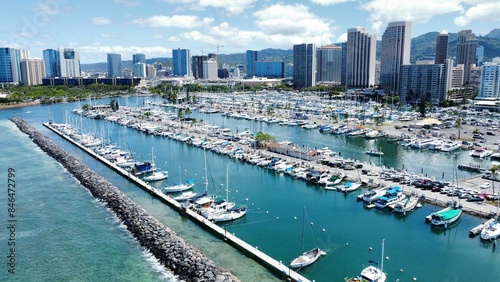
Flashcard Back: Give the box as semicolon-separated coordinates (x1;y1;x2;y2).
81;29;500;72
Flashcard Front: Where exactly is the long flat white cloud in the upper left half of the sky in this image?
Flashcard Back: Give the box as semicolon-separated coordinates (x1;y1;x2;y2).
132;15;209;29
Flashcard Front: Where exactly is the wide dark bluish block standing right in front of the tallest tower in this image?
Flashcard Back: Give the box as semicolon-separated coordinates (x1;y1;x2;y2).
398;62;446;105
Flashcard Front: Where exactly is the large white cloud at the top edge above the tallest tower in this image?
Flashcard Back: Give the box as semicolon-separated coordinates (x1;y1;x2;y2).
361;0;462;33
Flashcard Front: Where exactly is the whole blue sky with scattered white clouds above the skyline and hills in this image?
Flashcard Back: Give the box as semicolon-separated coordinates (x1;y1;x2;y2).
0;0;500;63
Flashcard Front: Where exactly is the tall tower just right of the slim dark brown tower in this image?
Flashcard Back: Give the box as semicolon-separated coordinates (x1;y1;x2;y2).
457;30;477;85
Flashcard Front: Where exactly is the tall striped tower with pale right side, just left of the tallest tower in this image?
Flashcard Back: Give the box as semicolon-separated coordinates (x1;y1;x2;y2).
345;28;377;88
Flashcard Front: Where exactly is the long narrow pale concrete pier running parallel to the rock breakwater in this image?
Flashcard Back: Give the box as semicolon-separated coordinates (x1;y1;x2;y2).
43;120;309;282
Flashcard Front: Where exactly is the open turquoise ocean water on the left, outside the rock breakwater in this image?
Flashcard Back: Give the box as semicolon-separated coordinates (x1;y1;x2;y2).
0;119;176;281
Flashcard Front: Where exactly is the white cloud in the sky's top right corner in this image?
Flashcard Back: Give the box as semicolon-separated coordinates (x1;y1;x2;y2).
454;1;500;26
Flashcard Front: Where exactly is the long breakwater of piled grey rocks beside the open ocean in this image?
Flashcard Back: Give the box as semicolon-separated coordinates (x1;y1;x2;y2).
11;117;239;282
